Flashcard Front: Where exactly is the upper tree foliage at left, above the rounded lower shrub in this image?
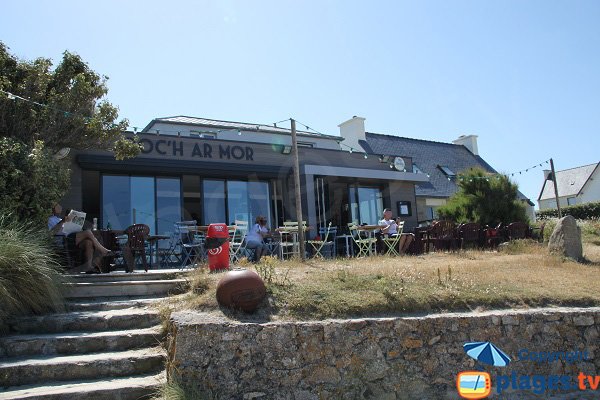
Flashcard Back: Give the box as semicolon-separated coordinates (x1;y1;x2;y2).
0;42;140;159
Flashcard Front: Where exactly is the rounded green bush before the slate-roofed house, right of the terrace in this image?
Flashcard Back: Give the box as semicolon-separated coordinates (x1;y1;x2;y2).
437;168;528;225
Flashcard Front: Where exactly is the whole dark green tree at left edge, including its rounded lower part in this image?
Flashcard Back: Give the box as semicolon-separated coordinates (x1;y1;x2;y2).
0;42;141;220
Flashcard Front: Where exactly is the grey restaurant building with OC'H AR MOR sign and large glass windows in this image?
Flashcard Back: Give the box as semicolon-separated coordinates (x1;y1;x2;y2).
63;116;428;235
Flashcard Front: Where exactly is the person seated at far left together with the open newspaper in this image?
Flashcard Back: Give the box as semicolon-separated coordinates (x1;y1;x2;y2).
48;204;112;273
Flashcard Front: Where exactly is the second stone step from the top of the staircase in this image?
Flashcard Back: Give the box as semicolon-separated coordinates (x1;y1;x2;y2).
64;279;188;298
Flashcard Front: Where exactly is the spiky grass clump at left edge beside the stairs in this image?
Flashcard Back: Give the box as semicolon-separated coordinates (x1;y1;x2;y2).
0;216;63;331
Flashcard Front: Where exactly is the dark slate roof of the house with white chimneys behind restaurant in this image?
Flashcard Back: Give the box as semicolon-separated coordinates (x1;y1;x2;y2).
361;132;533;205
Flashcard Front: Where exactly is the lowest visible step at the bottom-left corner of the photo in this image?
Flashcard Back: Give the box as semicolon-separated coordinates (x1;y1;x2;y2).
0;372;166;400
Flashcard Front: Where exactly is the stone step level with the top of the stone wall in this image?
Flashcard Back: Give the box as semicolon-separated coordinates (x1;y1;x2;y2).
9;308;161;334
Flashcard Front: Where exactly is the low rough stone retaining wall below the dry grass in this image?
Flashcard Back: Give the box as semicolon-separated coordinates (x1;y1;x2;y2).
169;308;600;400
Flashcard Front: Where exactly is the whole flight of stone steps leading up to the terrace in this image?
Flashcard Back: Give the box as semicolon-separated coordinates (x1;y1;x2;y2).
0;271;187;400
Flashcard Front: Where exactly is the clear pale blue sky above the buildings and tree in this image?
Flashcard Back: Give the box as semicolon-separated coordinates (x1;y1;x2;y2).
0;0;600;206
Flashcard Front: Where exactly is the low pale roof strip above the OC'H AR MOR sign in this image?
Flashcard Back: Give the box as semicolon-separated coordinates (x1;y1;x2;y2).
142;115;344;141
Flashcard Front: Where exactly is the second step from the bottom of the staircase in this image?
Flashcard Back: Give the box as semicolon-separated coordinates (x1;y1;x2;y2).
0;347;165;388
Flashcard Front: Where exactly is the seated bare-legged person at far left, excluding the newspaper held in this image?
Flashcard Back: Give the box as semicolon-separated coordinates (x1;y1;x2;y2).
48;204;112;273
